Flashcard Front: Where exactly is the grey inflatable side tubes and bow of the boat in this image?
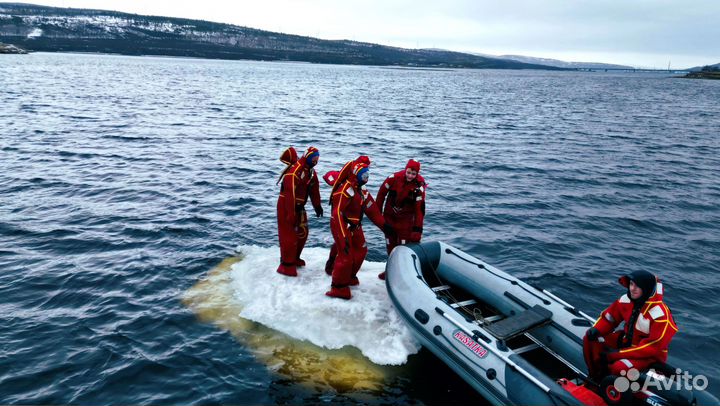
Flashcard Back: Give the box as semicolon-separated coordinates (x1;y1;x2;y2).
386;243;591;405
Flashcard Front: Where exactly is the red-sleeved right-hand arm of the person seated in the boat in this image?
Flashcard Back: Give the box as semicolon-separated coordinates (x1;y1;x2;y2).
608;303;677;361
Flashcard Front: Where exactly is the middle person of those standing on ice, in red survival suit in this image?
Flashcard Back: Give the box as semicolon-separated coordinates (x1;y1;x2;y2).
325;163;393;299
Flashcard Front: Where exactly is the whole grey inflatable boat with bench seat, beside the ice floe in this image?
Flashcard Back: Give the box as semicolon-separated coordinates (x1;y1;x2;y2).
386;242;718;406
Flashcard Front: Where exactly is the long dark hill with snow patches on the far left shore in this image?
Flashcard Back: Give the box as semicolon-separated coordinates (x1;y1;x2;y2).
0;3;558;69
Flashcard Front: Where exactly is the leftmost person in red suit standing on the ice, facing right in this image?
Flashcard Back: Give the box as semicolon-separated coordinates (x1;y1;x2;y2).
277;147;323;276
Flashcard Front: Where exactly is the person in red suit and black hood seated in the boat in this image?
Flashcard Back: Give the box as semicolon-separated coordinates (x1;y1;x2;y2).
583;271;678;382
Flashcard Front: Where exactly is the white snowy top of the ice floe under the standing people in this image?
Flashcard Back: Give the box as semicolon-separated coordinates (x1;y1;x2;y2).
231;246;420;365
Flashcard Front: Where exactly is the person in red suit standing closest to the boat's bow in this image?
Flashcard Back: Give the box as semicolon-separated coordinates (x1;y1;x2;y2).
376;159;427;280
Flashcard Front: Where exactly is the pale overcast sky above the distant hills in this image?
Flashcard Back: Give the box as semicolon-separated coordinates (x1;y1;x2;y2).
30;0;720;68
